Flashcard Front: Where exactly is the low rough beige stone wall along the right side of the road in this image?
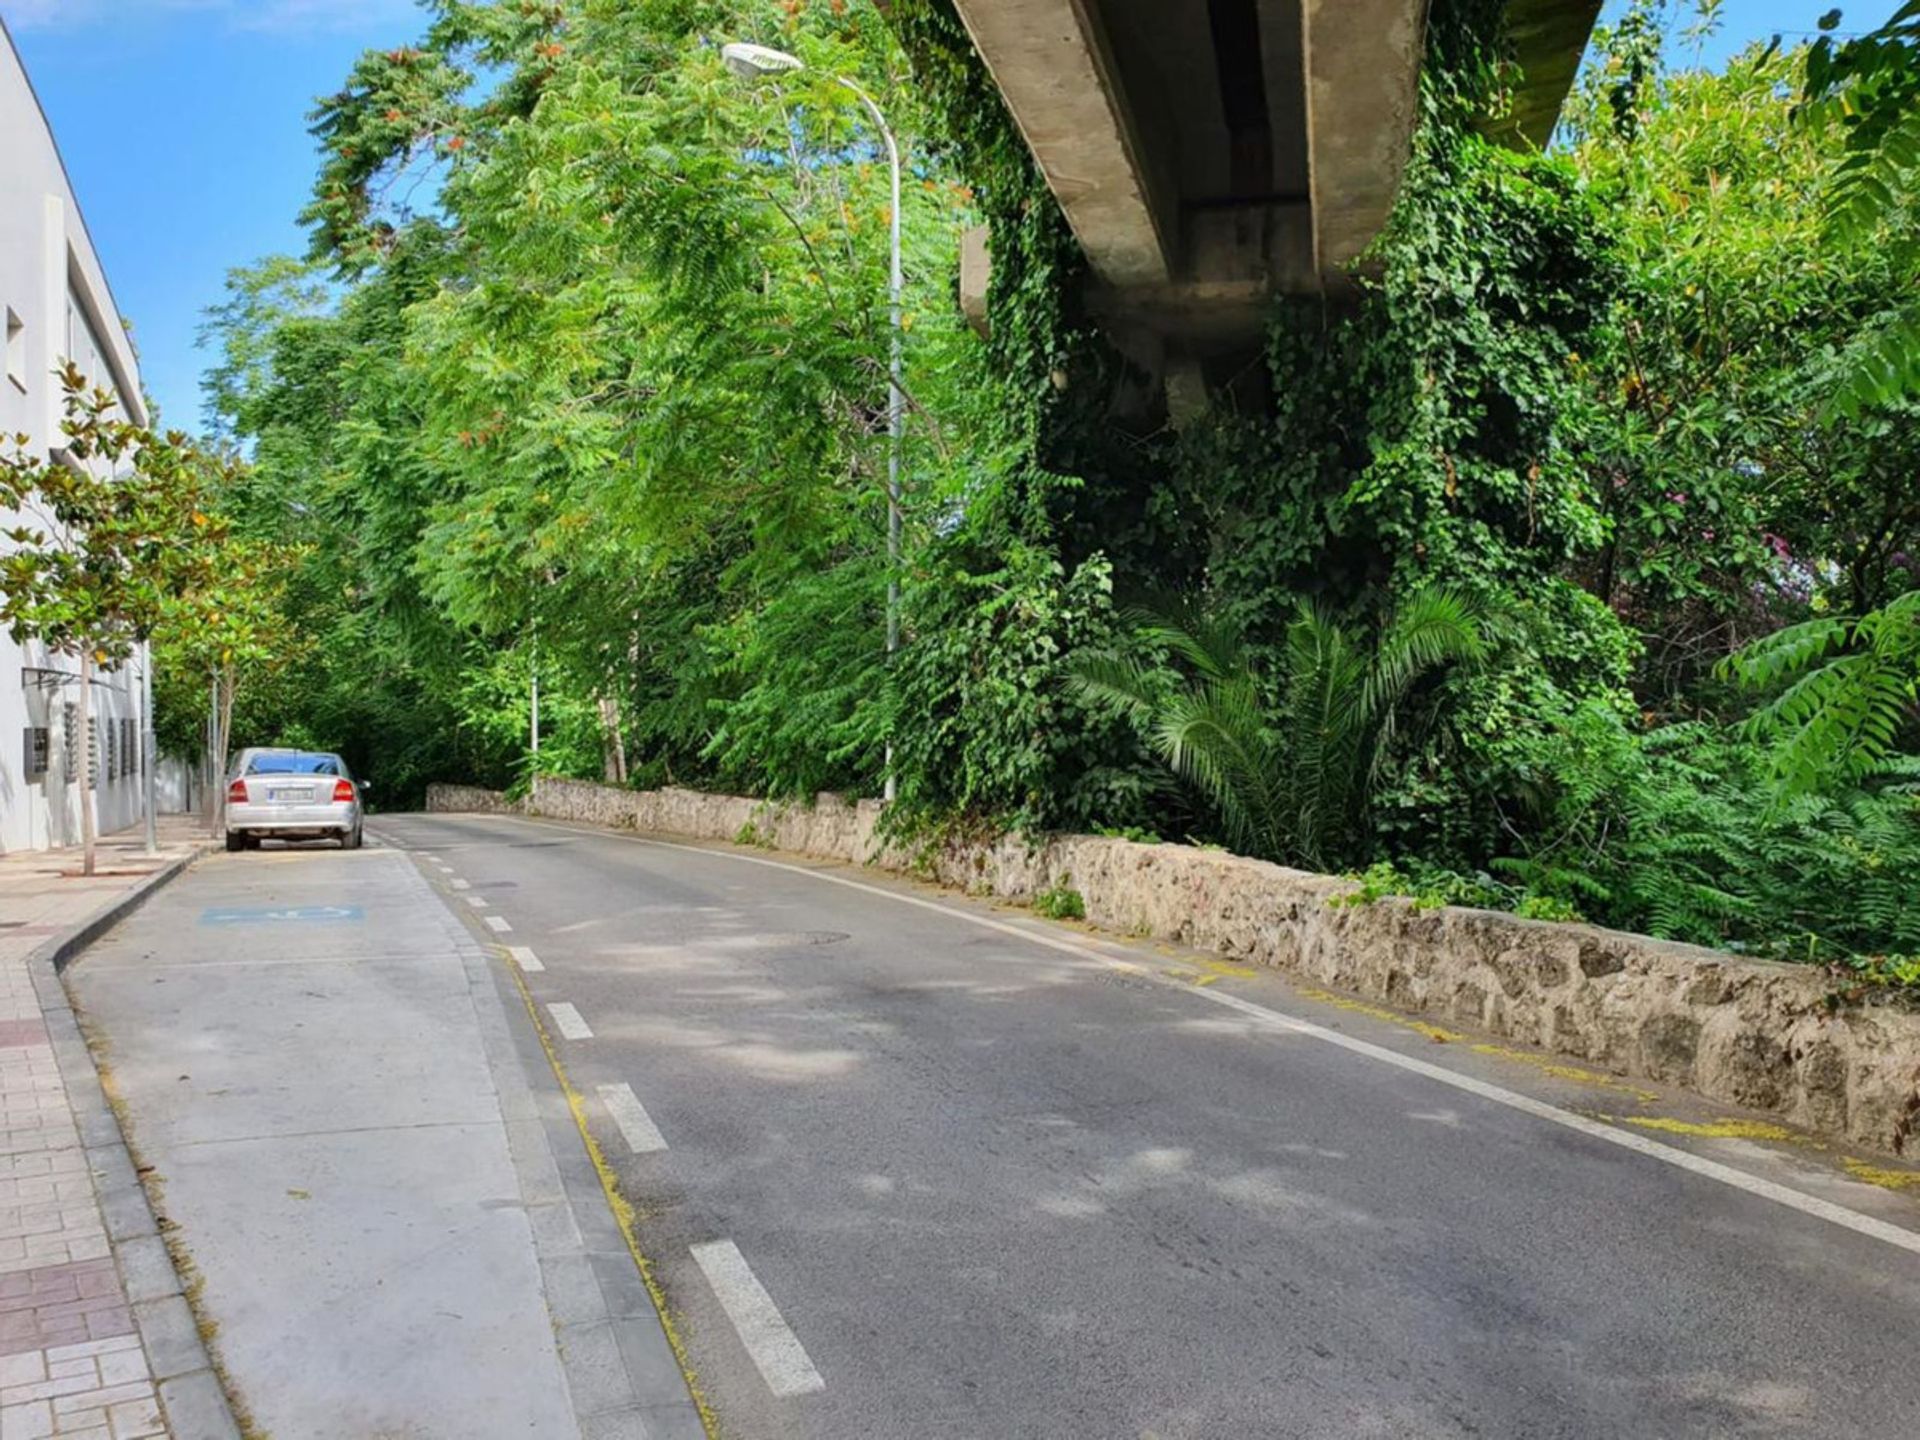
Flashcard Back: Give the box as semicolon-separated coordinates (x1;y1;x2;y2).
428;780;1920;1154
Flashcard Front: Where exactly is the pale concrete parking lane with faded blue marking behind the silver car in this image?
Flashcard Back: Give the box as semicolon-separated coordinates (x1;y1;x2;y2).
63;847;701;1440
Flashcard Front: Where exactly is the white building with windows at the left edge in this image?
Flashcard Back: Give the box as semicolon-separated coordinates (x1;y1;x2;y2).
0;21;146;852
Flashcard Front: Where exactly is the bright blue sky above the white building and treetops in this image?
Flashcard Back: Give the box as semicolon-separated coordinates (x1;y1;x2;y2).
0;0;1899;428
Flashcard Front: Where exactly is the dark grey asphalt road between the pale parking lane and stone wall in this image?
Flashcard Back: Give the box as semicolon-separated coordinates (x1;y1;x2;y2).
378;816;1920;1440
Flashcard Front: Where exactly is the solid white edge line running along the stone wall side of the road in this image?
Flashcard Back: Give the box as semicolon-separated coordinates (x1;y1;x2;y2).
495;818;1920;1254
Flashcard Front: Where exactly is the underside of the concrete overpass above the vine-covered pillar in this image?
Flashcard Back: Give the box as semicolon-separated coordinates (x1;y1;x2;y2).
956;0;1599;391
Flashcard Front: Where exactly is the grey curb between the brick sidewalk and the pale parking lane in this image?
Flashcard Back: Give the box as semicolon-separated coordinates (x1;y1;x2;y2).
27;841;242;1440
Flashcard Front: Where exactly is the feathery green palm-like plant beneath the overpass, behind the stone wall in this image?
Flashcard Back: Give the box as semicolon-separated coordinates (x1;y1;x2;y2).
1071;588;1486;870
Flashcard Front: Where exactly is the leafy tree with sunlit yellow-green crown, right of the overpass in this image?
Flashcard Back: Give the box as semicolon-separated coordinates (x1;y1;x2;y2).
1569;12;1920;695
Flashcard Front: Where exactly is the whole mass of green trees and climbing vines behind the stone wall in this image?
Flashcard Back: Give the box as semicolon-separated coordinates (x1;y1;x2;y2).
165;0;1920;975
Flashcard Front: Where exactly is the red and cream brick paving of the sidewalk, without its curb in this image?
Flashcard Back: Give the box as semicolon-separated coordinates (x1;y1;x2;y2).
0;816;211;1440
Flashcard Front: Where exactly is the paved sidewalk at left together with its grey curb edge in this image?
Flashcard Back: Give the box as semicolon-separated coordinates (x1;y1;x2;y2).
0;816;238;1440
